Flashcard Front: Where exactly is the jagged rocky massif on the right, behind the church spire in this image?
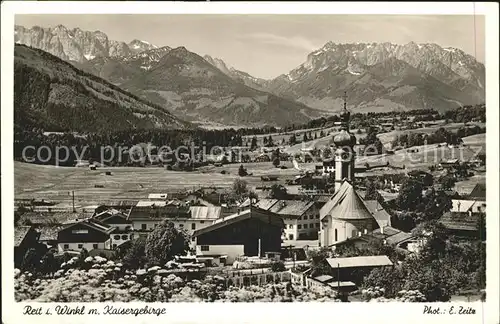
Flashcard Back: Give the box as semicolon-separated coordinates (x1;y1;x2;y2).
265;42;485;111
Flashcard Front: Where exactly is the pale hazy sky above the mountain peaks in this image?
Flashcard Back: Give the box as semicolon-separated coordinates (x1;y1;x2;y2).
15;14;485;79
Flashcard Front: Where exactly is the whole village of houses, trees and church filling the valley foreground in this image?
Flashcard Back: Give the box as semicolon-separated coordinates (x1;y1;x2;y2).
15;102;486;301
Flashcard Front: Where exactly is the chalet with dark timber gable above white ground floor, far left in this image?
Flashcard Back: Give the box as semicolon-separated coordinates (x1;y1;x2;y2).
57;218;115;253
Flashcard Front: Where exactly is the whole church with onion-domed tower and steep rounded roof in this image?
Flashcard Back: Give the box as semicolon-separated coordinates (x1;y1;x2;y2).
319;95;391;246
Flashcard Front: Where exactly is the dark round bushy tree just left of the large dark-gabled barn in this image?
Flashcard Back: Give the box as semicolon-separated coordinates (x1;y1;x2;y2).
145;220;189;266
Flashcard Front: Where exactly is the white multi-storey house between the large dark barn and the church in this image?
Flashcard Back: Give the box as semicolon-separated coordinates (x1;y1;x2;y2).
255;199;319;240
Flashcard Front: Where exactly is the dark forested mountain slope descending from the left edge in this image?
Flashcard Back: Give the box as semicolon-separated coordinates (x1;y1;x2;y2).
14;44;189;132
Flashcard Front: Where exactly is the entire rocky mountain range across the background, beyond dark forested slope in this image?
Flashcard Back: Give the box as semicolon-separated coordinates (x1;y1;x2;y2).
15;25;485;126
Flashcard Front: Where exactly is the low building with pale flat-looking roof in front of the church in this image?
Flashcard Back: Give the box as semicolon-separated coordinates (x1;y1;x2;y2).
323;255;393;285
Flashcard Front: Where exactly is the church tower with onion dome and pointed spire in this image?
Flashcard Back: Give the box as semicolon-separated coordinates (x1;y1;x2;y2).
333;92;356;191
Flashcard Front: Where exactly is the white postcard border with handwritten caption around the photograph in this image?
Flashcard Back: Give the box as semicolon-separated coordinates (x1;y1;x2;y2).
1;1;500;324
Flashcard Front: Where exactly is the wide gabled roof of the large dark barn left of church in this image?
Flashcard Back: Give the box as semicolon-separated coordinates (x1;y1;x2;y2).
193;207;284;237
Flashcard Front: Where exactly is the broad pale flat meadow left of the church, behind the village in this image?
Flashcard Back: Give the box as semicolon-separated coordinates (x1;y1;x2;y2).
14;162;311;207
